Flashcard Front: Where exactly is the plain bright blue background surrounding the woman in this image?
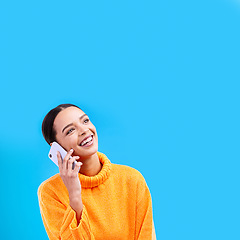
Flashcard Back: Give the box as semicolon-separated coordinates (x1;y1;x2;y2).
0;0;240;240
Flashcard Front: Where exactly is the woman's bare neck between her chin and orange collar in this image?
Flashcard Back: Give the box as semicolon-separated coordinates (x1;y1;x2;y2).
80;153;102;177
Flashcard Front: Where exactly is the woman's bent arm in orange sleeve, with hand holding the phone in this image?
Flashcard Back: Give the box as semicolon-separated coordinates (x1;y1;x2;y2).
38;149;95;240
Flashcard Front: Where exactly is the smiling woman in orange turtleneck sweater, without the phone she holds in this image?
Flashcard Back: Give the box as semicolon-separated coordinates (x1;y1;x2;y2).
38;104;155;240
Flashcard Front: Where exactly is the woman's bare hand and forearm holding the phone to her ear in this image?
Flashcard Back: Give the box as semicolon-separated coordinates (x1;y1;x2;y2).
57;149;83;222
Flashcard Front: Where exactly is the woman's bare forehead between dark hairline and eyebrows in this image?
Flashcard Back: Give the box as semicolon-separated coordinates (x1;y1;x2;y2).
53;107;85;129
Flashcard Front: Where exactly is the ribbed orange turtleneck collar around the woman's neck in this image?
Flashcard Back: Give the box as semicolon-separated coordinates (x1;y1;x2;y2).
79;152;111;188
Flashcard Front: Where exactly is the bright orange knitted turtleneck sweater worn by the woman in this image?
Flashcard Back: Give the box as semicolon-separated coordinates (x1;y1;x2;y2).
38;152;152;240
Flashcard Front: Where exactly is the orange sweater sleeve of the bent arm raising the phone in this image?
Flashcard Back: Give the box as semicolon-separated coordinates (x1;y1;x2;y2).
38;185;95;240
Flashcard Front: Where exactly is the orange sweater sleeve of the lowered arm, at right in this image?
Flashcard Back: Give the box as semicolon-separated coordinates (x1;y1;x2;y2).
136;174;153;240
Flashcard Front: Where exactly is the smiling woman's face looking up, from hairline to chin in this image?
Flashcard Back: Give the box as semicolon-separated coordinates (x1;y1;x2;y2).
53;107;98;161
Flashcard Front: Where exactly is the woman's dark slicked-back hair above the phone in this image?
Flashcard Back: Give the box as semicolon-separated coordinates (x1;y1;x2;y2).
42;104;82;144
